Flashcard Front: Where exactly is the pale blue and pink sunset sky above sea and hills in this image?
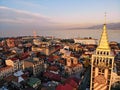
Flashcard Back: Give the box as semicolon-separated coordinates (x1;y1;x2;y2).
0;0;120;35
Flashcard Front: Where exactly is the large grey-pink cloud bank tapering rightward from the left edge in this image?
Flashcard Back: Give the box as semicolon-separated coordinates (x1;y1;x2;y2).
0;6;51;25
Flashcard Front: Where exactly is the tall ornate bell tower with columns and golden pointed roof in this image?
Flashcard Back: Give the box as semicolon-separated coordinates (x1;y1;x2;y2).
90;14;114;90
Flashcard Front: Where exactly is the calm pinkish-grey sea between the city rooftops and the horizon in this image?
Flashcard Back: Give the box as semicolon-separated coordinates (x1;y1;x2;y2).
0;29;120;43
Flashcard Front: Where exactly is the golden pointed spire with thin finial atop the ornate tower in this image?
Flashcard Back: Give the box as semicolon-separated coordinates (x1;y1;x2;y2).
98;12;110;49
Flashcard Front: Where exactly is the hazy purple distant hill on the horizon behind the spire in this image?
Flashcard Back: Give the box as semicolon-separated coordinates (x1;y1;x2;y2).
87;23;120;30
